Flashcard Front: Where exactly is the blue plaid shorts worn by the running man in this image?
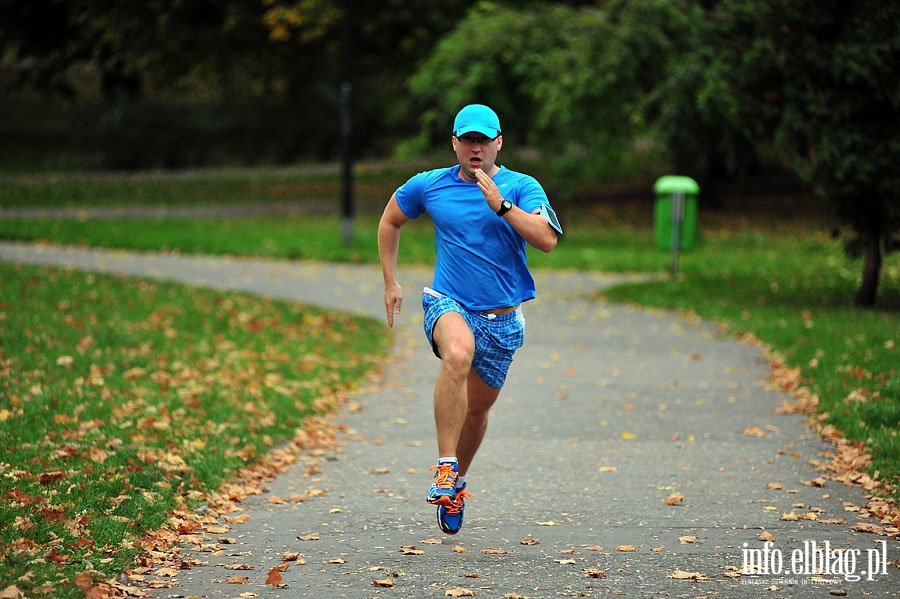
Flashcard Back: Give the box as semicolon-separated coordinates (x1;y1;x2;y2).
422;287;525;389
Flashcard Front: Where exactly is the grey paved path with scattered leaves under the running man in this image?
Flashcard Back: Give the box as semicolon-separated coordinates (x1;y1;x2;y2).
0;244;900;599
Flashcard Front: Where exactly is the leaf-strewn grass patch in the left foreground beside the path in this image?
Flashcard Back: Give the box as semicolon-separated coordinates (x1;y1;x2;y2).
0;263;386;598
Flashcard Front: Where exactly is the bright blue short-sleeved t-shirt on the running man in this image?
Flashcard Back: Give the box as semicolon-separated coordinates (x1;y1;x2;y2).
396;165;549;310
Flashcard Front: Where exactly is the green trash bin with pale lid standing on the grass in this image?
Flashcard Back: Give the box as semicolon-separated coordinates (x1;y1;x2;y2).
653;175;700;250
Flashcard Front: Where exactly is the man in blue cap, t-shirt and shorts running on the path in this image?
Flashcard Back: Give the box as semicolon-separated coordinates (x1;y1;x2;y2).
378;104;562;535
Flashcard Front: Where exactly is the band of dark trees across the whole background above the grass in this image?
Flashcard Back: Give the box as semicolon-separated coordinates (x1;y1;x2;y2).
0;0;900;305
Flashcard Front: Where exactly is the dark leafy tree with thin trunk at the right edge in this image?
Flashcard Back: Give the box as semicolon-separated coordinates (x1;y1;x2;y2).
660;0;900;305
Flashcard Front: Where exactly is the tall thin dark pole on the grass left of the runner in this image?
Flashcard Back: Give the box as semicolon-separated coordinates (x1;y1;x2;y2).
341;0;354;245
